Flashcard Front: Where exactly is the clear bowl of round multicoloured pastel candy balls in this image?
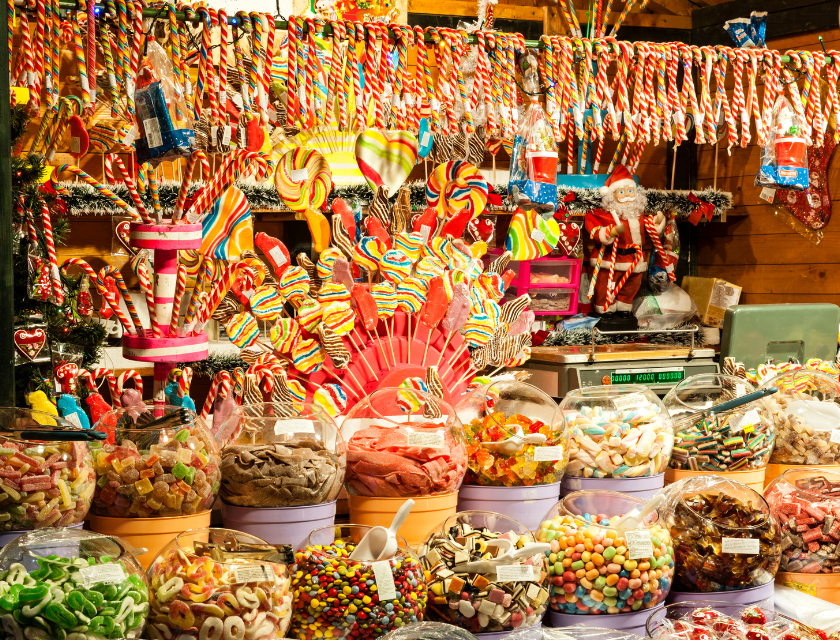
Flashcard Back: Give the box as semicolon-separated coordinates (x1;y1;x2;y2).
537;491;674;632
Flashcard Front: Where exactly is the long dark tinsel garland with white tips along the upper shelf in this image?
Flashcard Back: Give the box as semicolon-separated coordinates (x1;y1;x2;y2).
62;180;732;218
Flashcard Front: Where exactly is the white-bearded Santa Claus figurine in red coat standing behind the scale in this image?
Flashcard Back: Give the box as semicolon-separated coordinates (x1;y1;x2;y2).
585;165;665;331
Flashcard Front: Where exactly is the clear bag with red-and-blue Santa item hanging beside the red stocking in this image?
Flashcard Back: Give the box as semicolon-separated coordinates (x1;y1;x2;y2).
755;97;809;191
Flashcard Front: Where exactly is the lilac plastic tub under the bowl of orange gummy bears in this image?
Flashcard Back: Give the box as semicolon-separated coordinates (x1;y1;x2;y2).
458;482;560;531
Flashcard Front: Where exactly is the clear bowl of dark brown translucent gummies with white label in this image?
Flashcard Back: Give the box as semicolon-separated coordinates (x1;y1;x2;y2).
659;475;781;605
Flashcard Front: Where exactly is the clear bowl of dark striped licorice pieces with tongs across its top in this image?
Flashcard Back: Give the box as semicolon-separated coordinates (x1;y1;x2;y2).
662;373;776;492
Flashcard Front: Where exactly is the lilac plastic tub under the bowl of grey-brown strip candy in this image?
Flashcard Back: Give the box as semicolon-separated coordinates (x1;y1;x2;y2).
222;500;336;548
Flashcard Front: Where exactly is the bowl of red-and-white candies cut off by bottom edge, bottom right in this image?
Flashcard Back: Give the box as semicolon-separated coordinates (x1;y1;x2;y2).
647;594;824;640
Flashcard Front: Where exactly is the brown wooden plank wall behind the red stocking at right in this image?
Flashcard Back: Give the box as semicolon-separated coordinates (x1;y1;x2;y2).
697;27;840;304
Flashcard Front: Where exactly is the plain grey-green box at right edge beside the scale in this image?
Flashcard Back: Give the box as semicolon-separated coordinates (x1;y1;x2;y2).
720;303;840;369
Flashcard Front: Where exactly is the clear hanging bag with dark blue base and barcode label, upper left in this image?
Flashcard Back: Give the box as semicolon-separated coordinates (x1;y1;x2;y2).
134;41;197;166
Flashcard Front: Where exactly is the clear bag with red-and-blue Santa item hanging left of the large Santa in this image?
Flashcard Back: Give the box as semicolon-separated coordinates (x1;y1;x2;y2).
508;52;557;213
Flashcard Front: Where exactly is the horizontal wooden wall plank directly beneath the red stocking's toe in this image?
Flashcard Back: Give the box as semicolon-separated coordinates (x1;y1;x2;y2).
697;231;840;269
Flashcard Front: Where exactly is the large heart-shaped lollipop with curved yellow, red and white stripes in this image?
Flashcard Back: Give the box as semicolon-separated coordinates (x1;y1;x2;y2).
356;129;419;196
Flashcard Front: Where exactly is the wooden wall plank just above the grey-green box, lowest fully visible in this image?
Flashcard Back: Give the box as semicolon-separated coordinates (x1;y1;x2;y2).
697;264;840;295
